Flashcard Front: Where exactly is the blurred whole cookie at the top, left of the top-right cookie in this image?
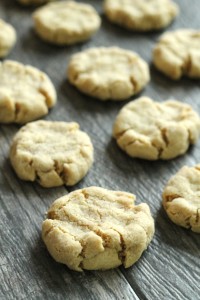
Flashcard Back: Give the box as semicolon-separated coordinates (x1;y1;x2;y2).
33;1;101;45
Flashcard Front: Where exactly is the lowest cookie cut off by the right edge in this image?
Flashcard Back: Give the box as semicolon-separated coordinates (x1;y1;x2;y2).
163;165;200;233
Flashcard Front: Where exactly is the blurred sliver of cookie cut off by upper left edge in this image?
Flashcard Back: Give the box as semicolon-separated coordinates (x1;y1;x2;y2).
0;19;16;58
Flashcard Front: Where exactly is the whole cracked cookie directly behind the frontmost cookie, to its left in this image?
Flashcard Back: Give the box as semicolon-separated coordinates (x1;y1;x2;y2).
10;121;93;187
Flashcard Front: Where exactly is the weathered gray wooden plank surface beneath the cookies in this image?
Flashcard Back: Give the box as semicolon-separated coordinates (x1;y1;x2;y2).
0;0;200;300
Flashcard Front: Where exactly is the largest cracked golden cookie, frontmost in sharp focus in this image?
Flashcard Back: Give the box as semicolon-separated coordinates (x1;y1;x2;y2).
42;187;154;271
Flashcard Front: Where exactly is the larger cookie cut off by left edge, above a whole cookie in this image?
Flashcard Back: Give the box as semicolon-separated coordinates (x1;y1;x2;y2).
0;61;56;124
